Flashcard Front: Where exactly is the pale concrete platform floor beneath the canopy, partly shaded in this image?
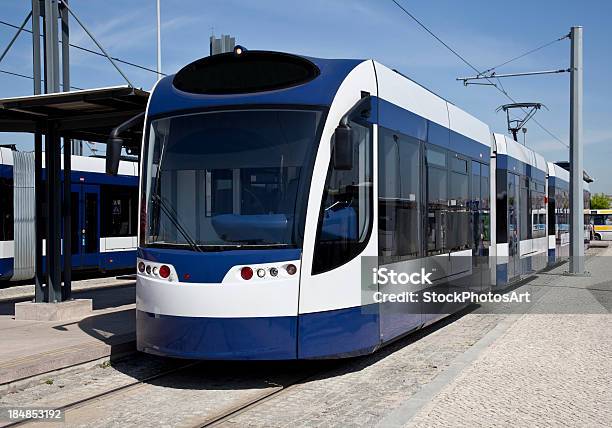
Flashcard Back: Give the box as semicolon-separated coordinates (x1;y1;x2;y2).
0;279;136;390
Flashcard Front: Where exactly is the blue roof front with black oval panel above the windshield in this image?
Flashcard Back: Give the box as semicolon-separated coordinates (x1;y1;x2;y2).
147;51;364;116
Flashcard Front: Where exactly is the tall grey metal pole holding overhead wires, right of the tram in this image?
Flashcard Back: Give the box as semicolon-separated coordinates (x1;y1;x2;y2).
569;27;584;275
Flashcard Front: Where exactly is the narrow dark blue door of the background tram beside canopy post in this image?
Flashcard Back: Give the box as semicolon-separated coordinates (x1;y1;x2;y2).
71;184;100;267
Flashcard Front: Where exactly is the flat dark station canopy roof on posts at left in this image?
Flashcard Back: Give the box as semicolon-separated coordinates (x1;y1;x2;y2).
0;86;149;152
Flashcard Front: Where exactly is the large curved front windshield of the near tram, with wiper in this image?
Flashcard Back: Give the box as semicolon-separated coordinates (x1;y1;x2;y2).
141;109;323;251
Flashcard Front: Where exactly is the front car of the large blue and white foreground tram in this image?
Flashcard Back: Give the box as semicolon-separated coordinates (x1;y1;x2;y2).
137;51;495;359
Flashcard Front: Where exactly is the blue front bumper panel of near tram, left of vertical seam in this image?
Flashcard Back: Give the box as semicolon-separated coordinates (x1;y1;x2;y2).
136;311;297;360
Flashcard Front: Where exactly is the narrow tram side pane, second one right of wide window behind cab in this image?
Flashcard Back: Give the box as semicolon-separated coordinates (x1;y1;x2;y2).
447;157;472;251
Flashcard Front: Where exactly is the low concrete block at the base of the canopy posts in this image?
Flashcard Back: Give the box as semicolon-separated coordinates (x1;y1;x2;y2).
15;299;93;321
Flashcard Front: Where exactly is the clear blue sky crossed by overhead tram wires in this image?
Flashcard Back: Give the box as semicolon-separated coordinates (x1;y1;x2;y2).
0;0;612;193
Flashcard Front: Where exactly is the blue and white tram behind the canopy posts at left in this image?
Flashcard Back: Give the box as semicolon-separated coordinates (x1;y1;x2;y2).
0;147;138;281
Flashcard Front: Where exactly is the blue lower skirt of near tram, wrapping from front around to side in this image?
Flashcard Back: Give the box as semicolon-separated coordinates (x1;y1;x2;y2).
136;307;380;360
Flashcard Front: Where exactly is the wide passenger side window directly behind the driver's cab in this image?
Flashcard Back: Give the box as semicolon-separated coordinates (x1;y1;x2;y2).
378;129;421;261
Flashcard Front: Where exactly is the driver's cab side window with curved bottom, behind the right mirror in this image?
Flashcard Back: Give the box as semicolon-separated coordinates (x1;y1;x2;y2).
312;117;373;275
